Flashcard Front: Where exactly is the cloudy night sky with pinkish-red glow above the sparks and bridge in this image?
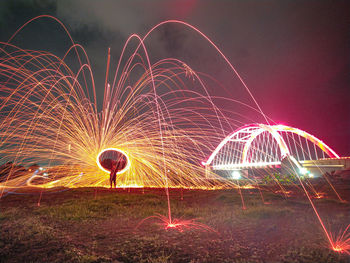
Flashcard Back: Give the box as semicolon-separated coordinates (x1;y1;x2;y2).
0;0;350;156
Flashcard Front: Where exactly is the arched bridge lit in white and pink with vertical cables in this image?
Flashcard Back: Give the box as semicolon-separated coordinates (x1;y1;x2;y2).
203;124;339;170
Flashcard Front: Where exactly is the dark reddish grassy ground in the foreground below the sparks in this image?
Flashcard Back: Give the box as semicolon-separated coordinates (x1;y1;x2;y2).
0;184;350;263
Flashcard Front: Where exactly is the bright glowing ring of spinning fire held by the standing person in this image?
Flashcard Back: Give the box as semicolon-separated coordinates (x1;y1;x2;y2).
96;148;131;174
